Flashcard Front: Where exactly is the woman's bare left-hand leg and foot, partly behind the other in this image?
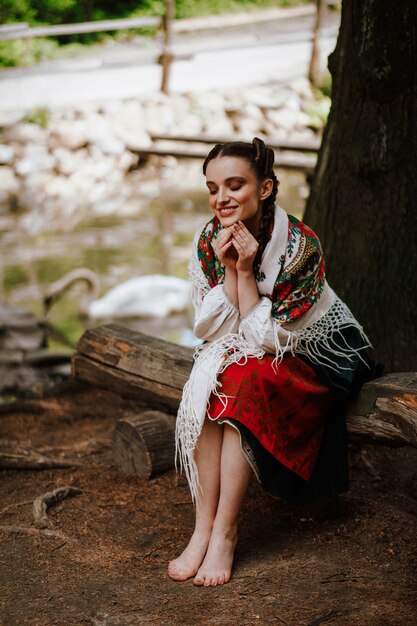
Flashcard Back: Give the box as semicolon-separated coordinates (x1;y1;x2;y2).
168;419;223;580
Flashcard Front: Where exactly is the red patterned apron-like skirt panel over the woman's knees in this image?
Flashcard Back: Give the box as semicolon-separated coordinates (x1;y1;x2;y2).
209;355;334;481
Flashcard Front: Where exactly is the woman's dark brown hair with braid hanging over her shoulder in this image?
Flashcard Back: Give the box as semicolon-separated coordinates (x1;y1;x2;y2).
203;137;279;249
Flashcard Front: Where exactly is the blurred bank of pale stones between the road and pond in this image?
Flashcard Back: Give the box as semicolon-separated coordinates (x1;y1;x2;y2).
0;81;329;233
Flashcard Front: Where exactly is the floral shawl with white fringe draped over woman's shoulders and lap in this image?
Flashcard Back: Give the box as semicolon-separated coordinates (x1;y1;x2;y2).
176;207;370;499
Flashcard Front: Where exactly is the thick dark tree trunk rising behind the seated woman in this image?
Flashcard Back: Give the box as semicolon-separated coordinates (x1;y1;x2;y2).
304;0;417;371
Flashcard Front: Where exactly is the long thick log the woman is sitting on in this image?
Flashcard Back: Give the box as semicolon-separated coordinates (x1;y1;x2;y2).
72;324;417;456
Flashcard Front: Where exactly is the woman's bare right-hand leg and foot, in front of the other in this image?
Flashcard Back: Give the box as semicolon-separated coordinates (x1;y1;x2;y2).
194;425;252;587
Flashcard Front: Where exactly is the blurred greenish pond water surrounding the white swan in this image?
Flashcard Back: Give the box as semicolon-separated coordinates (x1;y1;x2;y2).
0;160;308;350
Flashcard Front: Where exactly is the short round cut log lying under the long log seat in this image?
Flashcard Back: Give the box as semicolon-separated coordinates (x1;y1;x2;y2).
113;411;175;478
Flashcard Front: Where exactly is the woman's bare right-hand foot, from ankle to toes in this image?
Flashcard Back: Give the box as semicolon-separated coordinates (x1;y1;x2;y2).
193;529;237;587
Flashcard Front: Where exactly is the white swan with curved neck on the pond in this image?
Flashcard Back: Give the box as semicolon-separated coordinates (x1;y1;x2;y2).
44;268;191;319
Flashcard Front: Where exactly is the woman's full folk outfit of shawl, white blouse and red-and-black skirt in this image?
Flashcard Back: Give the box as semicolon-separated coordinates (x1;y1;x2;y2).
176;206;373;501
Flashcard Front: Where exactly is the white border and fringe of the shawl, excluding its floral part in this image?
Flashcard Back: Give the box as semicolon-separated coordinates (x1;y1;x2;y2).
175;207;370;500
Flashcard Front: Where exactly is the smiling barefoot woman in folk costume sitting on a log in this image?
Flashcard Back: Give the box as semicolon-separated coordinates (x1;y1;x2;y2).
168;138;371;586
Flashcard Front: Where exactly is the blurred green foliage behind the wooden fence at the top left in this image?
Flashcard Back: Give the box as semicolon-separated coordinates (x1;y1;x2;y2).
0;0;309;67
